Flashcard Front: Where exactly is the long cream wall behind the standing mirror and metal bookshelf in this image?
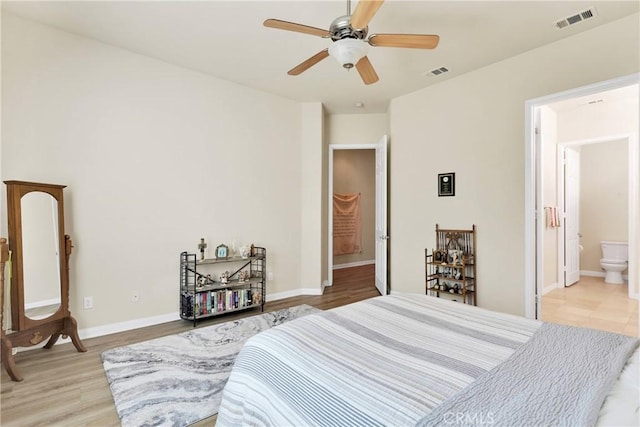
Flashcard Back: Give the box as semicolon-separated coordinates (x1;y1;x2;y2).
1;12;312;329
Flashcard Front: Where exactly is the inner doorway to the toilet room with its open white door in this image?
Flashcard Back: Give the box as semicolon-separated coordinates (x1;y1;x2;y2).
557;139;633;290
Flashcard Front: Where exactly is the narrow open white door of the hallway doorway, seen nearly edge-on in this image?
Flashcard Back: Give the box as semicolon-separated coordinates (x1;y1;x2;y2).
376;135;389;295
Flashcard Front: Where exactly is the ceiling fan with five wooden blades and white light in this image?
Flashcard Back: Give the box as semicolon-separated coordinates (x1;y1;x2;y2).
264;0;440;85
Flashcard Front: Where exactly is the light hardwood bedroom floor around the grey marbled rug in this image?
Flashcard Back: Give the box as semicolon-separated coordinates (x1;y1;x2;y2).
0;265;380;427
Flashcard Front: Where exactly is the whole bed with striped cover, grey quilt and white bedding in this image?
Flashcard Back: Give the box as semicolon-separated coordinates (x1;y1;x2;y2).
216;295;639;427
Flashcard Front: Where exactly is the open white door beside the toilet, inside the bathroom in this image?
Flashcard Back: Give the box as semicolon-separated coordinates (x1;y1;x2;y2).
564;147;580;286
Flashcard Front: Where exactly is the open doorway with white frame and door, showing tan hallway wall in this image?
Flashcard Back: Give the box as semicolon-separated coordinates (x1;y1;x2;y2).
327;135;388;295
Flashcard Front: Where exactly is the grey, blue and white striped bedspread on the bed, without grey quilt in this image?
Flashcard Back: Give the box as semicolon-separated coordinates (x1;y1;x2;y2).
216;295;542;427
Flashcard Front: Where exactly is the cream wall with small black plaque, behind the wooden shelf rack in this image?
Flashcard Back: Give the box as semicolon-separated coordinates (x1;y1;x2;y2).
390;14;640;314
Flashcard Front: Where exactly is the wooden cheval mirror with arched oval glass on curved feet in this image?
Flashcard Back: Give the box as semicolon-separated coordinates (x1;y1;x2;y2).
0;181;87;381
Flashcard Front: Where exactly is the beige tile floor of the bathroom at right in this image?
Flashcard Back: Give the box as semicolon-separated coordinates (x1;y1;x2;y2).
542;276;640;337
